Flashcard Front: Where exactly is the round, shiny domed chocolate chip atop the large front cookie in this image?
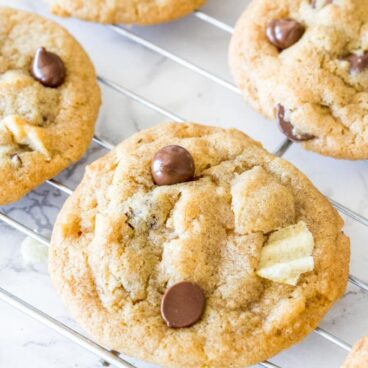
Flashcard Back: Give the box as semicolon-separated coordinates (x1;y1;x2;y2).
151;145;195;185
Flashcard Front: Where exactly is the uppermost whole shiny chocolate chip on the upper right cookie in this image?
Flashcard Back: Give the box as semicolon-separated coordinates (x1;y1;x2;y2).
266;19;305;50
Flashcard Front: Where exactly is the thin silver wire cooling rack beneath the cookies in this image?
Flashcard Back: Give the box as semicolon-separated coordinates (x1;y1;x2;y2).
0;3;368;368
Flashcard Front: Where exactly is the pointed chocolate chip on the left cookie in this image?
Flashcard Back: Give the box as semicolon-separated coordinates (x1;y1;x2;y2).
31;47;66;88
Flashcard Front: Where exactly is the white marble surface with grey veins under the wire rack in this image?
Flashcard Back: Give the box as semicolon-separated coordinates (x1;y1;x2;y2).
0;0;368;368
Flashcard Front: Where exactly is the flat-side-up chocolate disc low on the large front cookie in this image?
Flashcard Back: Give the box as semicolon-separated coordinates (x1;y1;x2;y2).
161;281;206;328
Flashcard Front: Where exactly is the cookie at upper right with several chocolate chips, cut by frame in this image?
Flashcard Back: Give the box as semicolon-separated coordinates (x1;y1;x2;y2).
230;0;368;159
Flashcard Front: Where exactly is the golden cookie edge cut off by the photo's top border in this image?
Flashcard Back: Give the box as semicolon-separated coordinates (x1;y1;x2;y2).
47;0;205;25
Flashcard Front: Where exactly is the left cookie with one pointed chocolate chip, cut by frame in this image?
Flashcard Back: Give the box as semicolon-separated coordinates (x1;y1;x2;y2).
0;8;100;205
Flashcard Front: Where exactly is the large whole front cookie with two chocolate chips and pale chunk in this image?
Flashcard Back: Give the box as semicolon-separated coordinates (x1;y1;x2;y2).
49;123;349;368
